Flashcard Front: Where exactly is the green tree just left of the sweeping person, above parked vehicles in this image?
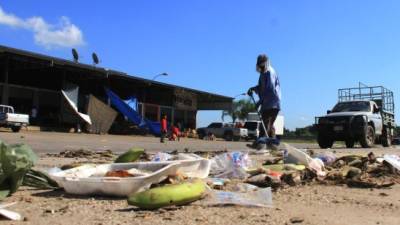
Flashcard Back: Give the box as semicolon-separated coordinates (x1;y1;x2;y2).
221;98;256;123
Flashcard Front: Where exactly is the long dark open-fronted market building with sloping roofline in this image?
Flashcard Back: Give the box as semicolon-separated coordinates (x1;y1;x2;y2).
0;46;233;134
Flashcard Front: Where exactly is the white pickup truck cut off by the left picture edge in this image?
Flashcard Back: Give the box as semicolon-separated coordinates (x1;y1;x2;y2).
0;105;29;132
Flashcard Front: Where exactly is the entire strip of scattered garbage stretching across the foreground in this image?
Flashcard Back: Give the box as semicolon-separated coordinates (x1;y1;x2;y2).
0;140;400;221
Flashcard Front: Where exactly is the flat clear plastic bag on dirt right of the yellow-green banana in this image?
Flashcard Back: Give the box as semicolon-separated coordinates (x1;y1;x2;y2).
203;184;272;207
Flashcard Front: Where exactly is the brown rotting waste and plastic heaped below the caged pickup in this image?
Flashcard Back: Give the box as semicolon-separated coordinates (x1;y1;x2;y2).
238;145;400;190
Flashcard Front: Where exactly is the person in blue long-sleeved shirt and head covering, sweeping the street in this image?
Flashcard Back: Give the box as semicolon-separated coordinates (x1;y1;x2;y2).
247;54;281;148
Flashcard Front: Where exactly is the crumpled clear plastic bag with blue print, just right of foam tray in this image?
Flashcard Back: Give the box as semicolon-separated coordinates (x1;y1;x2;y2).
210;152;252;179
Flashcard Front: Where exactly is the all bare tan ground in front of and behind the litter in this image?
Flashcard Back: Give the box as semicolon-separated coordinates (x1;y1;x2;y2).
0;132;400;225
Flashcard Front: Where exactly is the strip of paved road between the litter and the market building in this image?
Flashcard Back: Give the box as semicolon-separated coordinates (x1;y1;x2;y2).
0;131;400;154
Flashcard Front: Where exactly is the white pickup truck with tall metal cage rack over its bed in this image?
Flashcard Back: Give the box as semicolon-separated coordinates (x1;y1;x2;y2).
316;86;395;148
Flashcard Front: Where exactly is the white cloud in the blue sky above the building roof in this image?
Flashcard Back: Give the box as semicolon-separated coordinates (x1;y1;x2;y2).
0;7;85;49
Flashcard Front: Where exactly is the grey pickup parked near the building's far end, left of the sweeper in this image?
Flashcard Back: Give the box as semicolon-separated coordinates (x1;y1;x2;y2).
197;123;248;141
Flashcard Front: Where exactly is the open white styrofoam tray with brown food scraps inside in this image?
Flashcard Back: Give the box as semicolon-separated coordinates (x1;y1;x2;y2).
50;162;179;197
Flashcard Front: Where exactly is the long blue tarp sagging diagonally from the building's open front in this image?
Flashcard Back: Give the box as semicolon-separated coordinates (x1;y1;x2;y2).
106;88;161;135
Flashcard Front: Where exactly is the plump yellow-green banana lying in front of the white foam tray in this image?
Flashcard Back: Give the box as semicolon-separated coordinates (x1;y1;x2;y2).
128;179;206;209
